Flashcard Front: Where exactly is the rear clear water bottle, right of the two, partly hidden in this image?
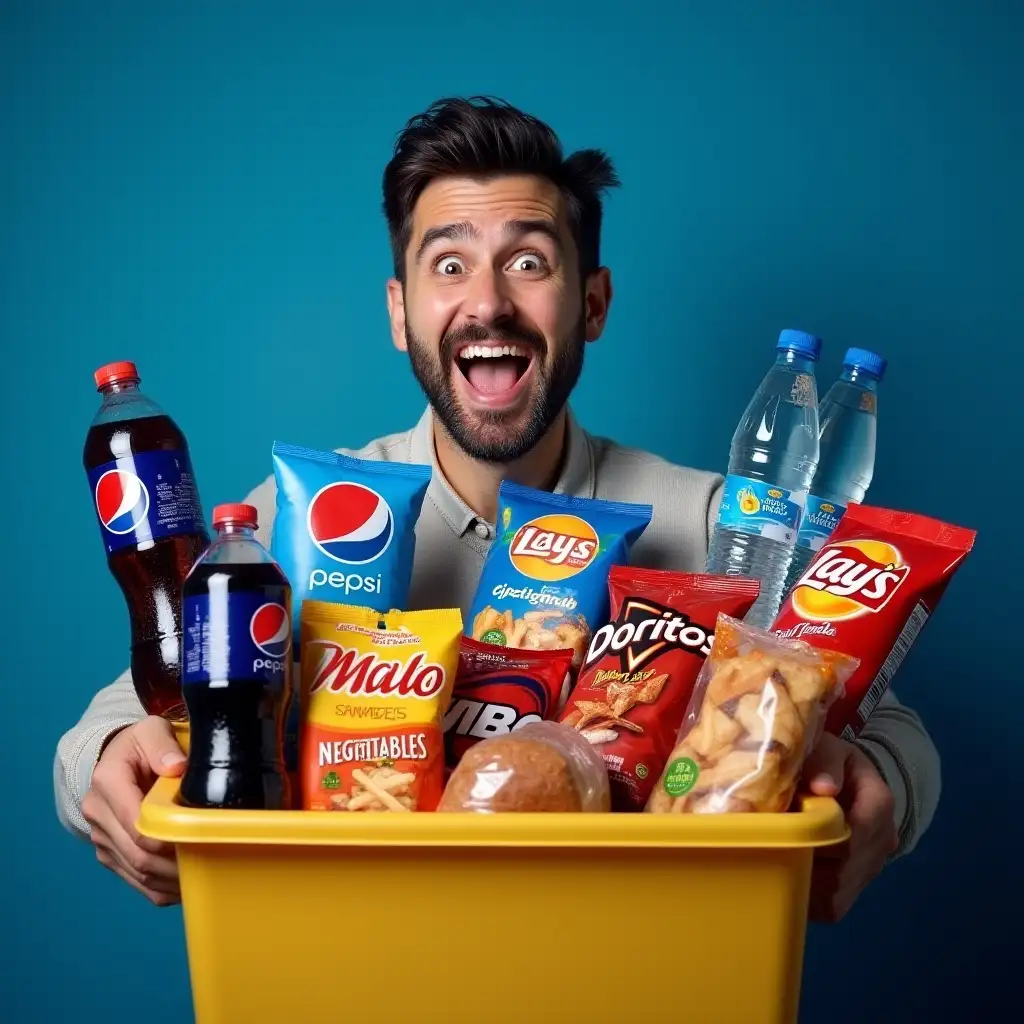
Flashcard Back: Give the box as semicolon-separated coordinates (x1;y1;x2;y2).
785;348;886;591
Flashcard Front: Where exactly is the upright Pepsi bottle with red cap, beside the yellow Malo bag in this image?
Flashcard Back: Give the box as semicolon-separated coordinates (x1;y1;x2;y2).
180;505;292;810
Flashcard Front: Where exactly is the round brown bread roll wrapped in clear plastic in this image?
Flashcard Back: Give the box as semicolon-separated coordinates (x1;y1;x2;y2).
437;722;610;814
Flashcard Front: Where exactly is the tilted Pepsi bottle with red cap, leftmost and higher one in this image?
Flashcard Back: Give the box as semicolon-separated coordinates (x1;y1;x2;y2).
84;362;210;720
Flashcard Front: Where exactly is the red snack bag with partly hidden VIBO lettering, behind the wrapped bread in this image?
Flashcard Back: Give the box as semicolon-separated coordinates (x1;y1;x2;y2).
444;636;573;768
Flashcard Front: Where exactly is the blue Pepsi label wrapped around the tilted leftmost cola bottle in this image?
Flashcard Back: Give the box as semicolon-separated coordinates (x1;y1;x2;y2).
89;450;205;555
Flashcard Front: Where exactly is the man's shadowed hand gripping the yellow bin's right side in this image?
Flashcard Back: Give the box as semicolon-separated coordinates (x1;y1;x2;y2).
804;732;899;922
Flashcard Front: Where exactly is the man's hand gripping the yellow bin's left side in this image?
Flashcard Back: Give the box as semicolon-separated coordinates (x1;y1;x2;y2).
82;715;185;906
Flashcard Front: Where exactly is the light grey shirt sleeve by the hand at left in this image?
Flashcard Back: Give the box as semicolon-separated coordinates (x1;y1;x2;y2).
53;670;145;839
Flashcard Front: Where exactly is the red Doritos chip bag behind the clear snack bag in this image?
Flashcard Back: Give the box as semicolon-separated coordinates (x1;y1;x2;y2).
559;565;761;811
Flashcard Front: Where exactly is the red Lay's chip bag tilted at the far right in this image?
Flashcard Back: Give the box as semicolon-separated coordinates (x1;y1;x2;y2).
772;505;977;739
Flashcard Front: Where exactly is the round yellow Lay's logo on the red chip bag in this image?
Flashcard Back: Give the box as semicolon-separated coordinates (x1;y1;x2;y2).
792;540;910;622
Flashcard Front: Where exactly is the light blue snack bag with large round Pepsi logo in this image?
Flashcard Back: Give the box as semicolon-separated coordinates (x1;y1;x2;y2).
270;441;430;771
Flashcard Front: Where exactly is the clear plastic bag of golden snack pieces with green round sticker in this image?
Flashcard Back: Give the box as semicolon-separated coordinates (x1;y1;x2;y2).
646;614;860;814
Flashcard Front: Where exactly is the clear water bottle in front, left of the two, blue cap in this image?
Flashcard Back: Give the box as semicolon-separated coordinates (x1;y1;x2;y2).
708;331;821;629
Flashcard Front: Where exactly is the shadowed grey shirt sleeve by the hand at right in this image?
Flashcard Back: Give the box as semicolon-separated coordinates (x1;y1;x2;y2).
855;690;942;858
